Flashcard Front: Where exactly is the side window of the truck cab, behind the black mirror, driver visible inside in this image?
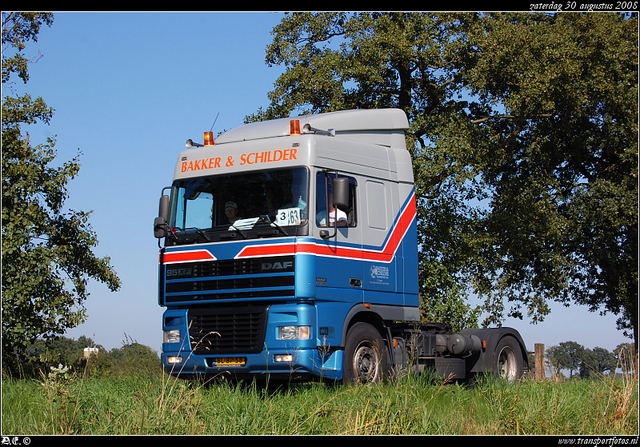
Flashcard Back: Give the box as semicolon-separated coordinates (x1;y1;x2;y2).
316;172;358;228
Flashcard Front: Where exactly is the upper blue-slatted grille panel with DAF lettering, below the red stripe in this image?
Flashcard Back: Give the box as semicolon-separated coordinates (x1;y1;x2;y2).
164;256;295;303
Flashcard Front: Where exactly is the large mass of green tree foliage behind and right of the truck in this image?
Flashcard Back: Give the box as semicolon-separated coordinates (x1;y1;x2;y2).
252;13;638;344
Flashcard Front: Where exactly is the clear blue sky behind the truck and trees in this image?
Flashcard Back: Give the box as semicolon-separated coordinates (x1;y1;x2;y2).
3;12;630;352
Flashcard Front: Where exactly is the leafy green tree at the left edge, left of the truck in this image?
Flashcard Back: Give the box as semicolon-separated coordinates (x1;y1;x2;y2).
2;13;120;372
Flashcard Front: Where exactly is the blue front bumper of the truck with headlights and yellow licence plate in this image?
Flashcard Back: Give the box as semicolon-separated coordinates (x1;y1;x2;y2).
161;303;343;380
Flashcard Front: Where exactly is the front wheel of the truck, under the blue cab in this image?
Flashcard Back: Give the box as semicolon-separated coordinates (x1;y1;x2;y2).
342;323;389;384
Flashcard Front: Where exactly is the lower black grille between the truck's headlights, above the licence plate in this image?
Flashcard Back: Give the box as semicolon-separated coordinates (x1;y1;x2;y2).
189;305;269;355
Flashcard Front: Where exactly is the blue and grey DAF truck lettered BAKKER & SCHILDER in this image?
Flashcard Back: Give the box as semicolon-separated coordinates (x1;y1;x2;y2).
154;109;528;383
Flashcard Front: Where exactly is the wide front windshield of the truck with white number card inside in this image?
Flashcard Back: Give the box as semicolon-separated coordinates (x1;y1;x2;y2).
169;168;308;237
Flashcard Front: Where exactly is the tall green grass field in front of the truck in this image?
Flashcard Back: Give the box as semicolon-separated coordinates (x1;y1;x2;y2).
2;372;638;435
